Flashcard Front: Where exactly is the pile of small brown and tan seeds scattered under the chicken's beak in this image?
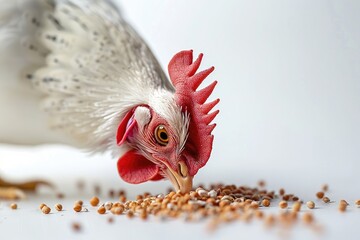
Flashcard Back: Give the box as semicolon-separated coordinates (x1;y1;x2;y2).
6;181;360;231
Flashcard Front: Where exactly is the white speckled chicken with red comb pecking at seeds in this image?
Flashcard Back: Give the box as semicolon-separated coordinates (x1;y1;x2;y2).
0;0;219;197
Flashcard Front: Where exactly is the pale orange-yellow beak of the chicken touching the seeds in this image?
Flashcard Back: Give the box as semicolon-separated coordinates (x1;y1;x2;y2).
164;161;193;193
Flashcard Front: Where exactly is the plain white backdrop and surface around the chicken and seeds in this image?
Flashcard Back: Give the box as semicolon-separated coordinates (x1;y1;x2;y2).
0;0;360;239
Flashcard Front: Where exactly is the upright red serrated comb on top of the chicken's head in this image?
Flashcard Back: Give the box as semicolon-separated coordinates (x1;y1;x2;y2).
168;50;219;176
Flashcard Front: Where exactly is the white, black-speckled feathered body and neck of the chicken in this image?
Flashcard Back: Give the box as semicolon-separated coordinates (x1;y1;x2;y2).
0;0;183;156
